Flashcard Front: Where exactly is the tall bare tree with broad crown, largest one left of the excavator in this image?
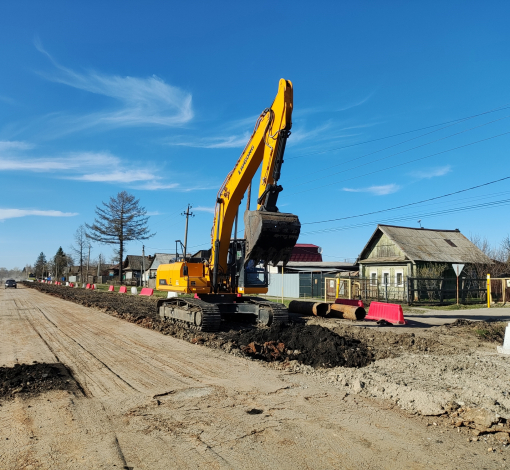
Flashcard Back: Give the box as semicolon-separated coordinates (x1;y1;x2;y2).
85;191;155;282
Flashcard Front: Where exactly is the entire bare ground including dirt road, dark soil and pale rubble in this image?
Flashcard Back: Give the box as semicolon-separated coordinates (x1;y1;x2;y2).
0;286;510;470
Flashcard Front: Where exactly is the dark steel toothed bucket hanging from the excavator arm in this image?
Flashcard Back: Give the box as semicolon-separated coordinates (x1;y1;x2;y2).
244;211;301;265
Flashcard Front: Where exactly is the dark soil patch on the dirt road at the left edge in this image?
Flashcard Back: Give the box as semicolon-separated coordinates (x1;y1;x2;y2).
0;363;81;399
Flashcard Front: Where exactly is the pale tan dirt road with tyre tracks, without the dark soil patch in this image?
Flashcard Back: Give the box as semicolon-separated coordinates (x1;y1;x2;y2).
0;288;506;470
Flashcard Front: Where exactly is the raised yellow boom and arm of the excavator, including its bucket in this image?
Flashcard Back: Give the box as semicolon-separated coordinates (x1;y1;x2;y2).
210;79;301;292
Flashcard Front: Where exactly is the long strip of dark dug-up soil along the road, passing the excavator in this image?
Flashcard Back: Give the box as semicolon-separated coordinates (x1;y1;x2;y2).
25;283;374;368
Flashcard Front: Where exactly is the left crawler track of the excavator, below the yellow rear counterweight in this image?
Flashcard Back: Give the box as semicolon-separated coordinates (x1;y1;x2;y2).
157;298;221;331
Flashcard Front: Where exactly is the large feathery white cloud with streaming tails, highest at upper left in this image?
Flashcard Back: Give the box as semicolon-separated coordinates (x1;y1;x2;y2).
35;40;193;132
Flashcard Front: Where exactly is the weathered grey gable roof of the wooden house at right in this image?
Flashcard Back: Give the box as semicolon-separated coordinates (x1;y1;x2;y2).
358;225;490;263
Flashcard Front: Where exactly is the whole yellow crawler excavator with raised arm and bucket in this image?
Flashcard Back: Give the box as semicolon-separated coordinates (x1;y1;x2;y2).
156;79;301;331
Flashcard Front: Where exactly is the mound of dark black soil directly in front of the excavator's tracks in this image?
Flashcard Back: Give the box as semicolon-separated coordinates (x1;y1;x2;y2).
226;323;374;367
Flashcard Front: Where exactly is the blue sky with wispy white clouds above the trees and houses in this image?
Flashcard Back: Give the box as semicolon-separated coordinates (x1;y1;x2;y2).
0;1;510;267
